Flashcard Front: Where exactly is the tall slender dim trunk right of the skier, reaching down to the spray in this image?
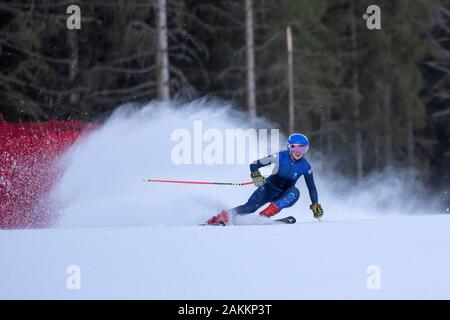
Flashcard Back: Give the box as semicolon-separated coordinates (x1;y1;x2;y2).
351;1;363;180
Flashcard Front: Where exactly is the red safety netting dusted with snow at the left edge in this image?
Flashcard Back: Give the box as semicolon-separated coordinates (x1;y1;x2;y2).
0;115;90;229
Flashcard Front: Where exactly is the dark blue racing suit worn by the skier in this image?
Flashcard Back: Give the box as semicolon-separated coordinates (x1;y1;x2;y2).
231;150;318;214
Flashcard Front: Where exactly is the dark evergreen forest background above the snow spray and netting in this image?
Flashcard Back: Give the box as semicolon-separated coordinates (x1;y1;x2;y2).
0;0;450;195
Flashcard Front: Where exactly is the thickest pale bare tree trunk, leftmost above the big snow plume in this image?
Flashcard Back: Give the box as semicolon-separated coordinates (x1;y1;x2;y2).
156;0;170;101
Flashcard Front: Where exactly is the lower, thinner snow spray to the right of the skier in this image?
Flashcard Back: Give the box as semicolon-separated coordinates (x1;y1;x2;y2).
302;162;445;220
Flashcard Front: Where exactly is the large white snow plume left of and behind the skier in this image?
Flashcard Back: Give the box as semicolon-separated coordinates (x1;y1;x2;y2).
51;99;280;227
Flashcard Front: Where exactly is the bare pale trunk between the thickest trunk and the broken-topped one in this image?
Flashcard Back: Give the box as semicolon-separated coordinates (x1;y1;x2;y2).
245;0;256;119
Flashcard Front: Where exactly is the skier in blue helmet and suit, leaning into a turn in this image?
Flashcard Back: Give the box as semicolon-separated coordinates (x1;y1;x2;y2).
206;133;323;225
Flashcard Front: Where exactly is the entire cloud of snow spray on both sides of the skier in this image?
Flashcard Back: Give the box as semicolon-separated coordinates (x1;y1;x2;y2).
51;99;442;227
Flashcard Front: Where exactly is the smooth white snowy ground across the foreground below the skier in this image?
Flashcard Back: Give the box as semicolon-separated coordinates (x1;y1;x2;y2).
0;215;450;299
